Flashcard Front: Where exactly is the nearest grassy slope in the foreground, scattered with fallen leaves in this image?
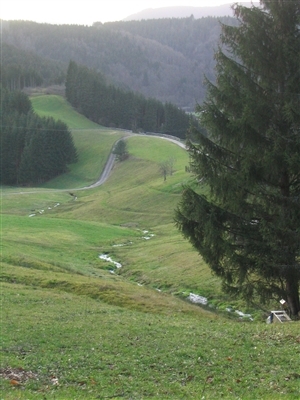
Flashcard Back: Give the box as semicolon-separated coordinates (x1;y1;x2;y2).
1;280;300;400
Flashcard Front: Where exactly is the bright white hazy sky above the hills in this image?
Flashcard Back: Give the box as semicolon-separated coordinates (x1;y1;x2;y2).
0;0;253;25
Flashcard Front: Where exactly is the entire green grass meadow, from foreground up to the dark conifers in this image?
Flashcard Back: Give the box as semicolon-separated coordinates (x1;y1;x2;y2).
0;96;300;400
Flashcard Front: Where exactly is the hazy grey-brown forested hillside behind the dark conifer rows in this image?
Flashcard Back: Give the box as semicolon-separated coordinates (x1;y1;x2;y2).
1;17;234;109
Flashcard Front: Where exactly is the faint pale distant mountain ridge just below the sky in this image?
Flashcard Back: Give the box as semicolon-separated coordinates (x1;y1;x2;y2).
123;1;259;21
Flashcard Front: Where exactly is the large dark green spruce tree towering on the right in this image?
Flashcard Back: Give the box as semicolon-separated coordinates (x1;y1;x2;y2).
176;0;300;315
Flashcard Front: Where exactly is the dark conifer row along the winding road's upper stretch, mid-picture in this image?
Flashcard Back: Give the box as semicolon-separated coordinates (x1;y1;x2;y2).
66;61;191;138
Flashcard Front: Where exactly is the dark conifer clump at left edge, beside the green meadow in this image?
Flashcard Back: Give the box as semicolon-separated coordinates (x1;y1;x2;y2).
0;85;77;185
